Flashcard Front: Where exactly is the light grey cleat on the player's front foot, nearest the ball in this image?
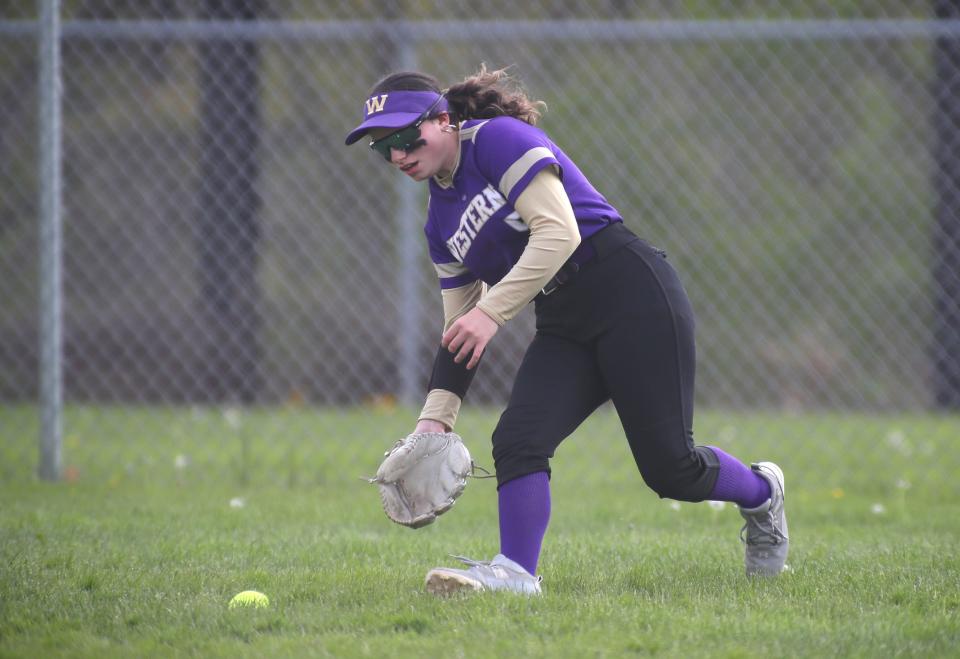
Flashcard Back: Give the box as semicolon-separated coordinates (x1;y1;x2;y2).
426;554;541;595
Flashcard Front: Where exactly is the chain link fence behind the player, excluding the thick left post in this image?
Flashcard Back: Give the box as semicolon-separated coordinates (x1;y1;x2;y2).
0;0;960;492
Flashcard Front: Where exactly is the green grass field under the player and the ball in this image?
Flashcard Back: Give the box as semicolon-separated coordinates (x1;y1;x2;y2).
0;407;960;657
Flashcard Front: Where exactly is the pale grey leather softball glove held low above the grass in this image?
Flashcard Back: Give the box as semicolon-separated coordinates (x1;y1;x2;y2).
368;432;473;529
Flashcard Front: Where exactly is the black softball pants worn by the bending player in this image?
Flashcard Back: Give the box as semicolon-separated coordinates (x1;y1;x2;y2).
493;223;719;501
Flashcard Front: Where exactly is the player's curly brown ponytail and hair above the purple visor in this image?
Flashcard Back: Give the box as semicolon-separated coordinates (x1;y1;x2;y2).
370;64;546;125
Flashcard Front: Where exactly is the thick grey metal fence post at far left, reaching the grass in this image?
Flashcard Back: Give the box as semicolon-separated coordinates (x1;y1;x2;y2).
38;0;63;481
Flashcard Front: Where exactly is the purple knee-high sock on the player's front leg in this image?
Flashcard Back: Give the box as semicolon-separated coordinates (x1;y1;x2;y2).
497;471;550;574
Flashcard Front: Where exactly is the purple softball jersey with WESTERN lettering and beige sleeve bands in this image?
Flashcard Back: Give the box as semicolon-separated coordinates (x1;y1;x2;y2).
424;117;622;288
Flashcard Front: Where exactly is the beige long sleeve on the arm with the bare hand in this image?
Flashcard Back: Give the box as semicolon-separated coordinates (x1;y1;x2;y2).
472;167;580;325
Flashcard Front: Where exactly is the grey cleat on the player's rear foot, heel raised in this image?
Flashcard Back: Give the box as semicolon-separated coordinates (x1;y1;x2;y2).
740;462;790;577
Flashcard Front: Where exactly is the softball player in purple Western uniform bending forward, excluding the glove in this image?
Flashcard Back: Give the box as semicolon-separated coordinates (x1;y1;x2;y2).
346;68;788;594
